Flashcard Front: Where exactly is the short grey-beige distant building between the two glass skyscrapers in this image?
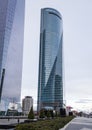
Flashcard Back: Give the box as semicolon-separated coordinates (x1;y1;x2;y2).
22;96;33;115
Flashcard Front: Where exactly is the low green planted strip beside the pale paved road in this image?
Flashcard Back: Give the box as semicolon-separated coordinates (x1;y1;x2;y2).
15;116;74;130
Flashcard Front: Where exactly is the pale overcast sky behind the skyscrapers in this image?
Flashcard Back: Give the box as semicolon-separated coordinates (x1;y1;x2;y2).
21;0;92;110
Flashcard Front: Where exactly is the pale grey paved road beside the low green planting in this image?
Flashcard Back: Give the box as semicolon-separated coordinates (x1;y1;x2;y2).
60;117;92;130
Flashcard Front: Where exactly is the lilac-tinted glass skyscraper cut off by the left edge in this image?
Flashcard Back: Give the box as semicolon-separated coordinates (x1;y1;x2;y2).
0;0;25;109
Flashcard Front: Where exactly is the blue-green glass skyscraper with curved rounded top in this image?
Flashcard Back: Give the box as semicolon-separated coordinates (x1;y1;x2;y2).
37;8;63;111
